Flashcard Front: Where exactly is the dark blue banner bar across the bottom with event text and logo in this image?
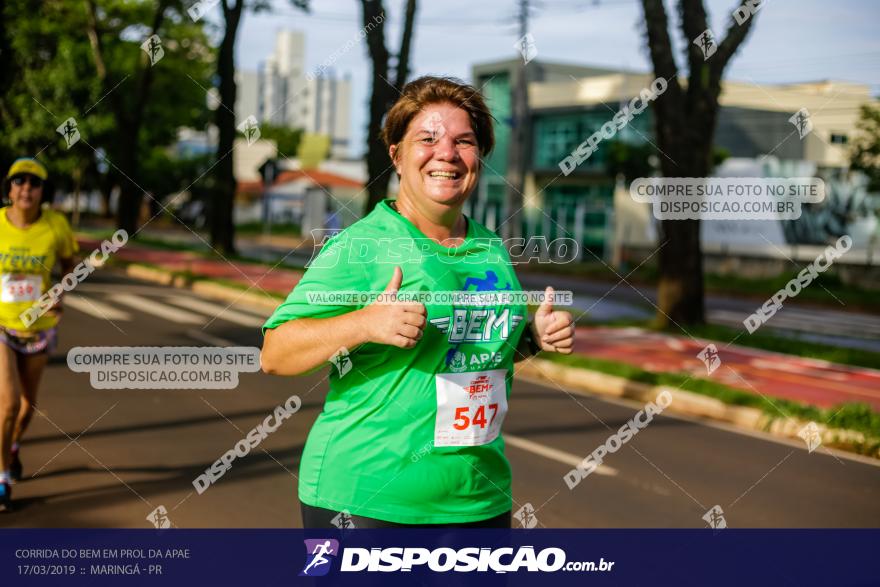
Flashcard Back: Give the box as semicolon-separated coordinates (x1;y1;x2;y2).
0;529;880;587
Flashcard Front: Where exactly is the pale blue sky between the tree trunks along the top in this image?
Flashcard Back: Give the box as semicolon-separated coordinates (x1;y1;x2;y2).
236;0;880;154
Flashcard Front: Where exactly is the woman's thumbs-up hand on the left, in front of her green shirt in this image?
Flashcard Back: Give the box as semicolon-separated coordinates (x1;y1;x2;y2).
361;267;427;349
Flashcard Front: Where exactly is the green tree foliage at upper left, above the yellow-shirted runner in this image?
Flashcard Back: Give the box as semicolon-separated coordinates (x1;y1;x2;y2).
0;0;214;230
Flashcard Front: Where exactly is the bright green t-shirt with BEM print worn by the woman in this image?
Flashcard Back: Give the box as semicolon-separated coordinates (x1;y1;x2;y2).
264;200;527;524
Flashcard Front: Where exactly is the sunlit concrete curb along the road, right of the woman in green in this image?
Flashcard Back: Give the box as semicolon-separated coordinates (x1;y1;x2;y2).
515;358;880;458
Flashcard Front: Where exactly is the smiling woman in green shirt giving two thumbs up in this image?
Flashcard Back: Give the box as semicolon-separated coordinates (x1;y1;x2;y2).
261;77;574;528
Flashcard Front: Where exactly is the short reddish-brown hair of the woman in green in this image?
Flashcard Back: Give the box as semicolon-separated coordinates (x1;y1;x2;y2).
382;75;495;157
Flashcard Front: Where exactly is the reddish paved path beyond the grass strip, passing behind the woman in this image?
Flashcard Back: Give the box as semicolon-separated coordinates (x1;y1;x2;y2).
79;238;880;410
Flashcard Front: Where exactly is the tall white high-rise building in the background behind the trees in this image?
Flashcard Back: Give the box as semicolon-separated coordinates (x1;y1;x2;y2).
235;31;351;156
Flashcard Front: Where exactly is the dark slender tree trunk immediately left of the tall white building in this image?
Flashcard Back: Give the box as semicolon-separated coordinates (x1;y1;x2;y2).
209;0;244;255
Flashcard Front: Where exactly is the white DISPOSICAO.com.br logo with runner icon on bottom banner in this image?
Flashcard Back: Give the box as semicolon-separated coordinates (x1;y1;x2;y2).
300;539;614;577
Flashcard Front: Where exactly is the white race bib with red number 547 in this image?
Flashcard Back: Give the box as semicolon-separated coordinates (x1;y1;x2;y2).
434;369;507;446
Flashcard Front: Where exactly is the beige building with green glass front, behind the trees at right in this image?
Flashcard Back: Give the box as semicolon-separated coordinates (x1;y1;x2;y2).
469;59;876;259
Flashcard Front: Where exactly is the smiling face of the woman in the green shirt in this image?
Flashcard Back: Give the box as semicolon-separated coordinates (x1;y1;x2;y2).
389;102;480;207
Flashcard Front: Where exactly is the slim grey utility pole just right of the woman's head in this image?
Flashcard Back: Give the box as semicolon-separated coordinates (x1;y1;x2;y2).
502;0;532;239
